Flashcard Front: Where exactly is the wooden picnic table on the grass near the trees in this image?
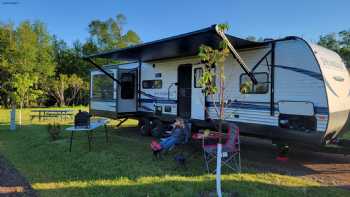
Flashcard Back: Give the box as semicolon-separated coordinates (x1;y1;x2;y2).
30;109;74;121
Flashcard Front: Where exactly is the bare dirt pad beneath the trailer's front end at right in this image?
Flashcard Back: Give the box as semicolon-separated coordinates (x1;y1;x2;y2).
241;137;350;189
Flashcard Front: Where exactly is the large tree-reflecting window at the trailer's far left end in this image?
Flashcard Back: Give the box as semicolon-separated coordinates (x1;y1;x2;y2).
92;73;114;100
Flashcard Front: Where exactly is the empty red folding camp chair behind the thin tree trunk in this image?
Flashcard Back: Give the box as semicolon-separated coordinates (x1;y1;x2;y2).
202;123;241;173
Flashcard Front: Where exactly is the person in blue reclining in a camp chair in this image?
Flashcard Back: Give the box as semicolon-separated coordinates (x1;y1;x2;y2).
151;118;185;150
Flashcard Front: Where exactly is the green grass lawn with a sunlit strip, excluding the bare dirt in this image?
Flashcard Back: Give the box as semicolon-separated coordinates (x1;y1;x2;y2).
0;107;350;197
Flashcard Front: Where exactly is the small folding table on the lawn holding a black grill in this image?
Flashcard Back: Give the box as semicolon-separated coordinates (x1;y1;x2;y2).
65;118;108;152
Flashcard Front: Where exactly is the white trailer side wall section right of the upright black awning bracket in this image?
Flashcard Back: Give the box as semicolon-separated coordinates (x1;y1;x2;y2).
275;39;329;132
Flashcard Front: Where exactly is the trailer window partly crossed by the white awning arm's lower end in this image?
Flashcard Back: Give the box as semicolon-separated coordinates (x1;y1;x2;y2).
239;73;269;94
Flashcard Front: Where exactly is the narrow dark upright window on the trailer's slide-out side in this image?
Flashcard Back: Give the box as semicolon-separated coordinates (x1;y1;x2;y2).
120;73;135;99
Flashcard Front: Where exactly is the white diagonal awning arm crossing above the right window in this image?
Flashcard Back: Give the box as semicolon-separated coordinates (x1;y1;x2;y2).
215;25;258;84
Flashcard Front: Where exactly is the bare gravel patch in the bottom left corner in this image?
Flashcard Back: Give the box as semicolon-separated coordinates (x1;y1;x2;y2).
0;156;37;197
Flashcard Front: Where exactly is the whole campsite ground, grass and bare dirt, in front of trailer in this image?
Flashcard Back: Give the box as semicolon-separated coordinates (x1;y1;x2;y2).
0;108;350;196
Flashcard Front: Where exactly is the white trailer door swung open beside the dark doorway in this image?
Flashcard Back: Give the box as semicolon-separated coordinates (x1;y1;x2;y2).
191;65;205;120
